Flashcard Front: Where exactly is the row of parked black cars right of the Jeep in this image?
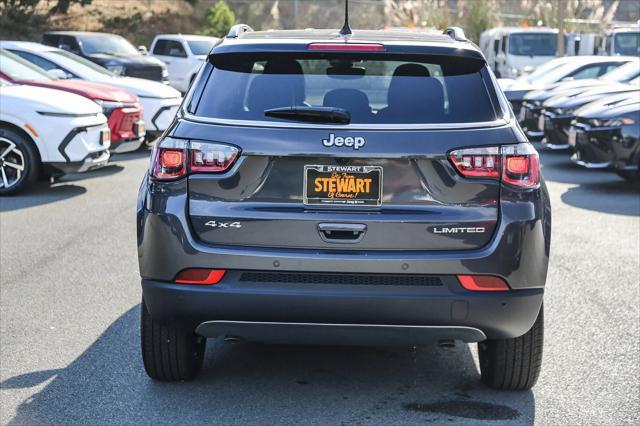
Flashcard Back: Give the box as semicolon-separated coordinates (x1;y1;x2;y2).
499;56;640;181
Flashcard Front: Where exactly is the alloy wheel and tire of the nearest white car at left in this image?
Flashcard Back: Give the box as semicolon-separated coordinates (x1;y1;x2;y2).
0;127;41;196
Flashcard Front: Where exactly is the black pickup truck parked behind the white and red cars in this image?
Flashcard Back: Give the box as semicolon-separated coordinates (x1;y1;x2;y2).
41;31;169;84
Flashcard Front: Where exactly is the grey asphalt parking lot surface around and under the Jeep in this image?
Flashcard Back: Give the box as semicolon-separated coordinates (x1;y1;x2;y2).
0;147;640;425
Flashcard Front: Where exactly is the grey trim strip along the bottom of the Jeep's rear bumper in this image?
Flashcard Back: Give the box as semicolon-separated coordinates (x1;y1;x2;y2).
196;321;487;346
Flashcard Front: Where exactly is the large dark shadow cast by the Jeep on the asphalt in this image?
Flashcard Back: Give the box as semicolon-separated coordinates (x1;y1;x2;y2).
0;306;535;424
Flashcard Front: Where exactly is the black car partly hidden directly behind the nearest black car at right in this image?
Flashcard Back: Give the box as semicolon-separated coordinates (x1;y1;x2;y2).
541;79;640;149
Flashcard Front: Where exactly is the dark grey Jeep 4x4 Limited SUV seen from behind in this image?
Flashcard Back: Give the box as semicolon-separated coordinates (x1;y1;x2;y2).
137;25;551;389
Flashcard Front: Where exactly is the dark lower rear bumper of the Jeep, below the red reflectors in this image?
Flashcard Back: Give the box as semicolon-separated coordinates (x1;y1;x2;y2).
142;271;543;344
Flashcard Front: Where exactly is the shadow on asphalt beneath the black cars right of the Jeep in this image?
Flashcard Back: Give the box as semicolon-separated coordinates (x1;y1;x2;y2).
540;151;640;216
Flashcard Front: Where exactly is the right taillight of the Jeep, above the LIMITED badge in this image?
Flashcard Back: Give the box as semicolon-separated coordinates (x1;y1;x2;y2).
449;143;540;188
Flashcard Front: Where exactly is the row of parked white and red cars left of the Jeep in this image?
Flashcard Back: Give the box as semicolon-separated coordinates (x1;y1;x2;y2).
0;32;200;195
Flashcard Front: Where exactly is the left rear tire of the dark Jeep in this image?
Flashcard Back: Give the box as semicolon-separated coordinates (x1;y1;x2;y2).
140;298;207;382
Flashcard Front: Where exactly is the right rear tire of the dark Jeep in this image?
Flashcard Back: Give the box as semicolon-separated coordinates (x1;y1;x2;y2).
478;306;544;390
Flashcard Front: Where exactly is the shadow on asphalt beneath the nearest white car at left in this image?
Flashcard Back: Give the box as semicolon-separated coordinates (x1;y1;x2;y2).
0;182;87;212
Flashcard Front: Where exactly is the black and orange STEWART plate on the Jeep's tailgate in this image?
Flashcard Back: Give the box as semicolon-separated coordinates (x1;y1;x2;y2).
304;165;382;206
